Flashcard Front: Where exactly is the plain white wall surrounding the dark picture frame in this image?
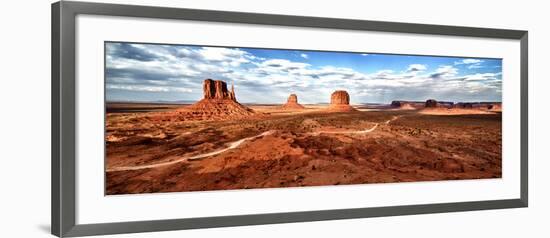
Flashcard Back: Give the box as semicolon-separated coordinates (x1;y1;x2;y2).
0;0;550;238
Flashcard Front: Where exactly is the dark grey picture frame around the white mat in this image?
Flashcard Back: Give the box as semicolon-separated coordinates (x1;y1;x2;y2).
51;1;528;237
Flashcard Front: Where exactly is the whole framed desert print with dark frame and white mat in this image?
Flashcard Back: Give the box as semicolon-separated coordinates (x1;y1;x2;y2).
52;1;528;237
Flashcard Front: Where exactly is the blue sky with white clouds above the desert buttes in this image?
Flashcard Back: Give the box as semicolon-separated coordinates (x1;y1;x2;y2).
105;43;502;103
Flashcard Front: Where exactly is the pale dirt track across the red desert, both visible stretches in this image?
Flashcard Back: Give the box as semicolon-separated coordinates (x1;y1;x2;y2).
106;116;401;172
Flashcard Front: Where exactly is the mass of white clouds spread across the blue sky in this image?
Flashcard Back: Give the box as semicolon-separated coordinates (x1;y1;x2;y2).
107;44;501;103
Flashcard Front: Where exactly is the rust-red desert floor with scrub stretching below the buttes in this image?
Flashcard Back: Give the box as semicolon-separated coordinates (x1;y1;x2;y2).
106;105;502;194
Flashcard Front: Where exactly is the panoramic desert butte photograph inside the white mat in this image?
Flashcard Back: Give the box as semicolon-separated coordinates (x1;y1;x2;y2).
105;42;503;195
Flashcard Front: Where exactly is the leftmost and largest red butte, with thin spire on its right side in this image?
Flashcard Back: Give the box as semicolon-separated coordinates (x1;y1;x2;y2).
180;79;255;120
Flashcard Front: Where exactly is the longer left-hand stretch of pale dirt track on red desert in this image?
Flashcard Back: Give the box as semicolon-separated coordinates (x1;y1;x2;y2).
106;131;273;172
